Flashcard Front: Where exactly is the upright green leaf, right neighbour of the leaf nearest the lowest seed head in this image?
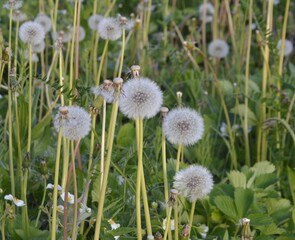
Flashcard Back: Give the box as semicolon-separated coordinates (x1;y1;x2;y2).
235;188;254;218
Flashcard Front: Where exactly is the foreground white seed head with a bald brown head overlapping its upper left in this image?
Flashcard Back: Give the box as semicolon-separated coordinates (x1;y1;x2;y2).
54;106;91;140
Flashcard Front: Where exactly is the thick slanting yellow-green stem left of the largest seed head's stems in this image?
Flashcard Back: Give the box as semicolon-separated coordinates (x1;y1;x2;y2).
94;100;118;240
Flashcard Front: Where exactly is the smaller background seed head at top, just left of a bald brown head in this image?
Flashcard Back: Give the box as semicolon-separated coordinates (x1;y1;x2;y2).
98;18;122;41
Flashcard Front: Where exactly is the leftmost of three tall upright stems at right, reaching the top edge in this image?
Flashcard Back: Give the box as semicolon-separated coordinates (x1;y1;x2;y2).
243;0;253;166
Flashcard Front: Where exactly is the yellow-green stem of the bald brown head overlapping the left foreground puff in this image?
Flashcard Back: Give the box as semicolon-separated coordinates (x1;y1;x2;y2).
51;128;62;240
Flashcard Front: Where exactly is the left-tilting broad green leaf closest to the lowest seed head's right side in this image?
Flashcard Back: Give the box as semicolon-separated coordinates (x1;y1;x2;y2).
214;196;239;222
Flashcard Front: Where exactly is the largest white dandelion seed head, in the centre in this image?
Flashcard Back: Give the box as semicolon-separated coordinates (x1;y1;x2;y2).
119;77;163;119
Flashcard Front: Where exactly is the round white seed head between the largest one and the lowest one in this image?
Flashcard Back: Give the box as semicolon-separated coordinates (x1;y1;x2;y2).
163;108;204;146
